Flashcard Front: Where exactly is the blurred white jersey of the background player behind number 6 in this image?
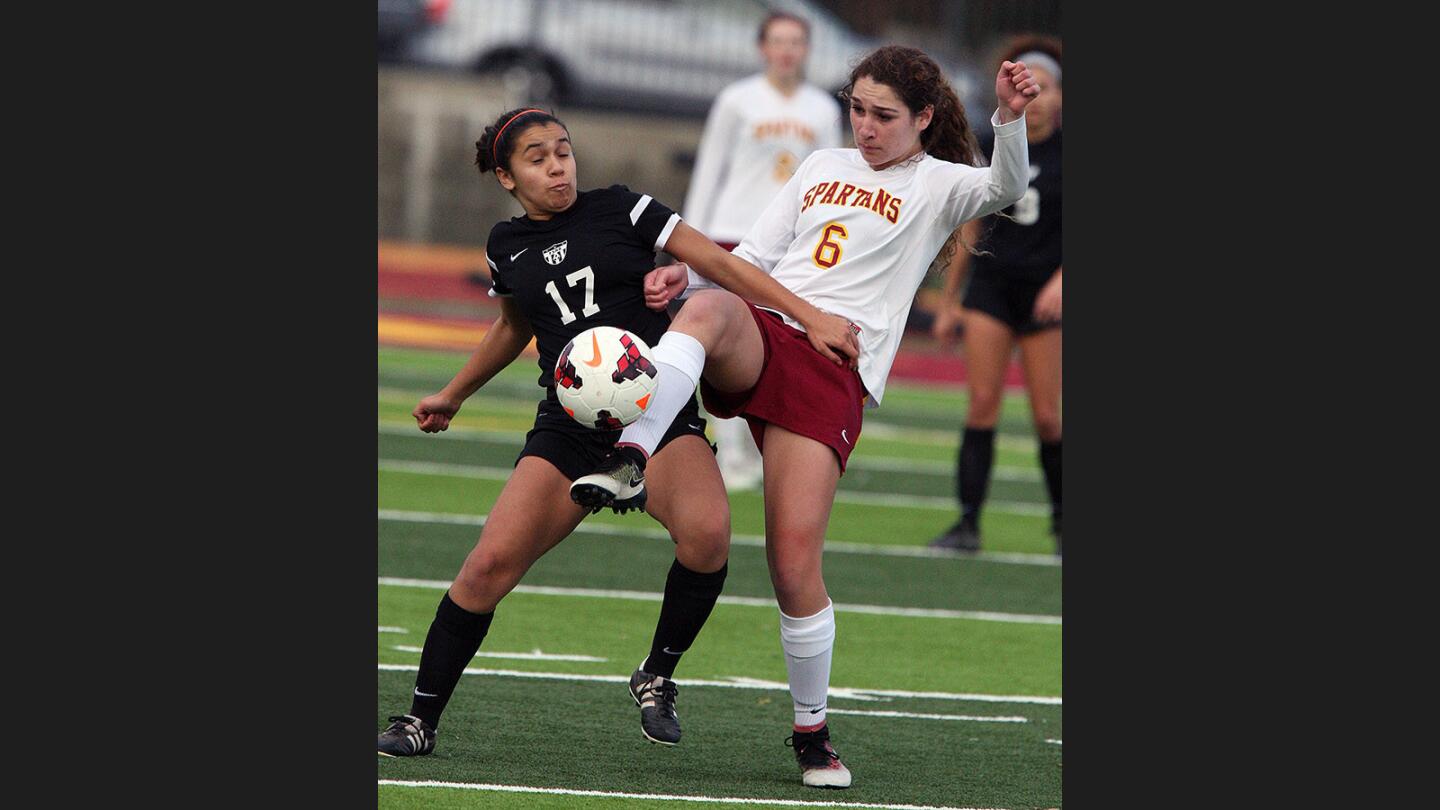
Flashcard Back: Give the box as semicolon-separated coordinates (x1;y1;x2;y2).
681;74;841;242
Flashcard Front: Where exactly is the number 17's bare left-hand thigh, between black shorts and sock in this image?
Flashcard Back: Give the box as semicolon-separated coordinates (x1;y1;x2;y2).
451;455;585;613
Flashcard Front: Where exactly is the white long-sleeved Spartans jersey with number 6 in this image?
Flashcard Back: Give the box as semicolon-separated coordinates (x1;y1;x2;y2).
685;111;1030;408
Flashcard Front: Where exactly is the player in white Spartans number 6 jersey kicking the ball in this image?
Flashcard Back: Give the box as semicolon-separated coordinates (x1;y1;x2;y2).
570;46;1040;787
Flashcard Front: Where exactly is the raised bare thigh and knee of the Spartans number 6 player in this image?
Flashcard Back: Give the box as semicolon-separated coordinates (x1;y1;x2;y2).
670;290;765;392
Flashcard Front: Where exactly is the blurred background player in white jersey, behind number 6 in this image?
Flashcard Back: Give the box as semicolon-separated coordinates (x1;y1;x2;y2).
684;12;841;490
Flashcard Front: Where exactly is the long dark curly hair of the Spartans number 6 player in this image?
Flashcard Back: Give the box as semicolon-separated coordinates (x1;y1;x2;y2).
841;45;985;166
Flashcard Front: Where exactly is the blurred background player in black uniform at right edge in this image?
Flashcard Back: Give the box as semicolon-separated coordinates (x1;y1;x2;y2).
930;36;1061;553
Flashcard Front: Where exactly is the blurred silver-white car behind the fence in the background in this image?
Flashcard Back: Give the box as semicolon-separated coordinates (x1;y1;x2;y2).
382;0;973;115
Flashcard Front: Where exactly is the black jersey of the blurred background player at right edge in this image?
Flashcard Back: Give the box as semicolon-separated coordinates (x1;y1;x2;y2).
973;130;1061;281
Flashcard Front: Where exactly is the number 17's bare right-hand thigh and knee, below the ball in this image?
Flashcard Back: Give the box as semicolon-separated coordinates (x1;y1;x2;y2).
645;435;730;574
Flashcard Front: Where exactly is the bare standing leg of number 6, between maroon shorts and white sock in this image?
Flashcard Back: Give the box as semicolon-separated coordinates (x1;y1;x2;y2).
763;424;840;617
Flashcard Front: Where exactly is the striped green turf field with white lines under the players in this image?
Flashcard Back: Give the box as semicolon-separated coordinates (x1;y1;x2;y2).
376;347;1063;809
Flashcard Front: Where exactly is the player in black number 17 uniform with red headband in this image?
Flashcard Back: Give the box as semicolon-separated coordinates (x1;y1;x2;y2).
379;110;748;757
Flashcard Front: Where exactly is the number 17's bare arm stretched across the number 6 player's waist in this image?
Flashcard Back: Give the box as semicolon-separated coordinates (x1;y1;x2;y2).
665;222;860;368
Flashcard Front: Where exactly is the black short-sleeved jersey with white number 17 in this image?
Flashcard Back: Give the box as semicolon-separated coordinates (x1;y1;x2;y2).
485;186;680;388
